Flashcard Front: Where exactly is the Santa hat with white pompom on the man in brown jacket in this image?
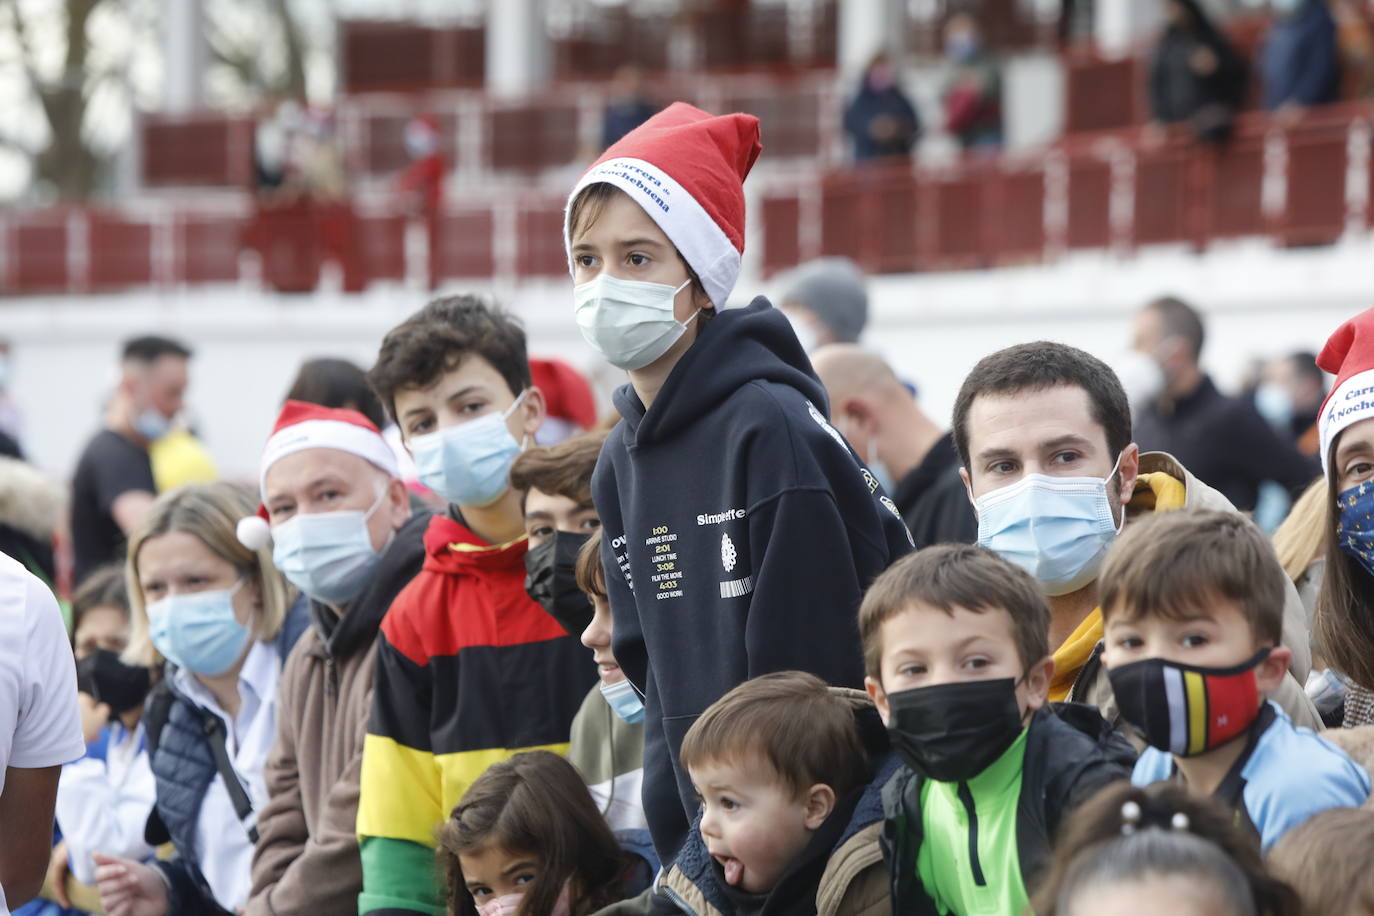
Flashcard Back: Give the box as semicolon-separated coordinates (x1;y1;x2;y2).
238;401;400;551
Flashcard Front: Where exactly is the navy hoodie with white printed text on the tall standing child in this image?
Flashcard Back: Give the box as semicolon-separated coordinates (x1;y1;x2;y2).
592;298;911;862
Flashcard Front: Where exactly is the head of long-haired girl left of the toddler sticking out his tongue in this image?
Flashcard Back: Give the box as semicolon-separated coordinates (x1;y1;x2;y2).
438;751;653;916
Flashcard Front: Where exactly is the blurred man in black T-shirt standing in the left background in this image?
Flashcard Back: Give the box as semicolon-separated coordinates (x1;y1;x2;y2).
71;335;191;584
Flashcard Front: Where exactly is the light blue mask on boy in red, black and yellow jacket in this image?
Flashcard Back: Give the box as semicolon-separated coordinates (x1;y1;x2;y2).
411;389;529;508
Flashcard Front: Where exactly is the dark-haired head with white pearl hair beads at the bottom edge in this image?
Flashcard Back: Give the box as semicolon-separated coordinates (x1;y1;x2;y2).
1032;781;1301;916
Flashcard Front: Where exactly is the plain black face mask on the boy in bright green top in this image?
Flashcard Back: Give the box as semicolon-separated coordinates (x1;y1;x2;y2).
888;677;1022;783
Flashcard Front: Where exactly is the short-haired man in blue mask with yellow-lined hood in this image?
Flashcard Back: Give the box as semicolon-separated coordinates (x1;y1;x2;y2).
954;341;1320;728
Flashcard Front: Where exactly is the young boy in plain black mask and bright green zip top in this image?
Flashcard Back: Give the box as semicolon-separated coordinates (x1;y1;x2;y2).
859;544;1135;916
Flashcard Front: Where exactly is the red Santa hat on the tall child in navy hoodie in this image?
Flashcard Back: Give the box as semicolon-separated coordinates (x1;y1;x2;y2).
563;102;763;309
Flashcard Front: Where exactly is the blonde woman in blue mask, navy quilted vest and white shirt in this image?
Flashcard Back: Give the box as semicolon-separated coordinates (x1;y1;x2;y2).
95;483;306;916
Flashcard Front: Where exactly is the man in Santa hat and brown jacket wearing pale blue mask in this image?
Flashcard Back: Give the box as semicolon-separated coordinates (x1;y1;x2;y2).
239;401;429;916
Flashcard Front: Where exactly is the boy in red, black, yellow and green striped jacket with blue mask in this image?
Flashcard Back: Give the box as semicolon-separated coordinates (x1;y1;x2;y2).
357;297;595;913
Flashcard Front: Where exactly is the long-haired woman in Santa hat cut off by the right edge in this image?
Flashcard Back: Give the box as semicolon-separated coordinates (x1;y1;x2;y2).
1314;309;1374;728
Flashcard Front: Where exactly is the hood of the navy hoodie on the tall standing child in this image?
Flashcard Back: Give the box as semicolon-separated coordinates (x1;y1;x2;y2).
614;297;830;449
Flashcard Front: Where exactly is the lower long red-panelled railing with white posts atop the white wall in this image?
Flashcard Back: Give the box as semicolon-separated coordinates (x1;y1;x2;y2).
10;103;1374;294
